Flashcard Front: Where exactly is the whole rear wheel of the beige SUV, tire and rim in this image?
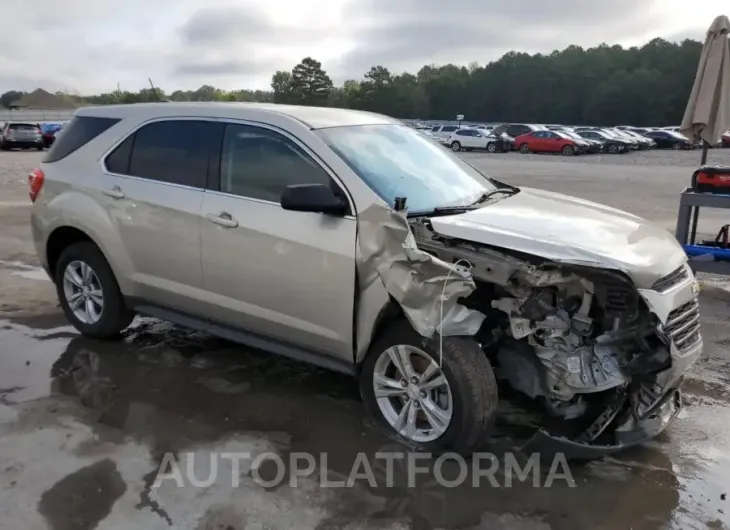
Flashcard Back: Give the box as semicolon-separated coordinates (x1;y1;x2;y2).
55;242;134;339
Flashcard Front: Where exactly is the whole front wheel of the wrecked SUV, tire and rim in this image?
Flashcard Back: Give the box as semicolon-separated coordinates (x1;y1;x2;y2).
360;321;498;455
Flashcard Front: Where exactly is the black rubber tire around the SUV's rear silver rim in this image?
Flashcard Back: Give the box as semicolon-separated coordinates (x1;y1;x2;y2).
54;242;134;339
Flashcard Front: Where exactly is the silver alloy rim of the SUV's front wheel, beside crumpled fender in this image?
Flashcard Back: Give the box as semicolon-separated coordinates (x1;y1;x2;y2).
373;345;454;443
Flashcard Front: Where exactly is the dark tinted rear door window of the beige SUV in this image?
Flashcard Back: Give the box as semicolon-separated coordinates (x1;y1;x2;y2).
110;120;222;188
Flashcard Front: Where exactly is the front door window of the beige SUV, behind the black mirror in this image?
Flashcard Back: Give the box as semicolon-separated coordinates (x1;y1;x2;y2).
220;124;332;203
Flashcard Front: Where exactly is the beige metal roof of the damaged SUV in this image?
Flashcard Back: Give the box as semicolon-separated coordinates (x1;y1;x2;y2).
76;101;400;129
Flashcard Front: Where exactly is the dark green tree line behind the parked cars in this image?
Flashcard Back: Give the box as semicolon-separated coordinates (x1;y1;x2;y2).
0;39;702;126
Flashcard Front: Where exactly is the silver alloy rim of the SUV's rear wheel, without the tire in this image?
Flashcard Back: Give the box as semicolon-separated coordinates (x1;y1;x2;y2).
63;260;104;324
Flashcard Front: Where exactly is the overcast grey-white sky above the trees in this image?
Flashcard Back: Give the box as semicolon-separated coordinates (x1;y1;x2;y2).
0;0;730;94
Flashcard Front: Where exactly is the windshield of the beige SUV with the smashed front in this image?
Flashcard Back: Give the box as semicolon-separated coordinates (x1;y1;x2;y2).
316;125;496;212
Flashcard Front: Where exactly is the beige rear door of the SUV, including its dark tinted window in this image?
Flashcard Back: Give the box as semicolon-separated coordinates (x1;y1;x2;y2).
103;119;223;313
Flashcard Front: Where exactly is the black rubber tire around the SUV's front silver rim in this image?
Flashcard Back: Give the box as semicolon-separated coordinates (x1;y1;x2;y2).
360;320;498;456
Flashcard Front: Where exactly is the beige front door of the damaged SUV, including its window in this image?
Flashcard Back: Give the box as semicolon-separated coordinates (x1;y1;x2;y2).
201;123;357;360
